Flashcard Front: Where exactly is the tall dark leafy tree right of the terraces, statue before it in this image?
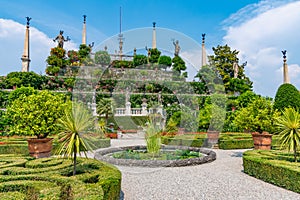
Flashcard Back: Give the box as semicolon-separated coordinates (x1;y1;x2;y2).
209;45;252;93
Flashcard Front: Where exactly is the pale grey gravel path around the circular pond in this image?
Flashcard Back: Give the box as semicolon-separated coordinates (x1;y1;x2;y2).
95;139;300;200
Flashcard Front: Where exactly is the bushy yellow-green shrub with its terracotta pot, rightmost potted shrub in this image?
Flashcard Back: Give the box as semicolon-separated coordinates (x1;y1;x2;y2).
233;97;279;150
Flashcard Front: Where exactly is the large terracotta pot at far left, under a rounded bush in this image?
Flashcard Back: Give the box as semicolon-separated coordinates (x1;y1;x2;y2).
27;138;53;158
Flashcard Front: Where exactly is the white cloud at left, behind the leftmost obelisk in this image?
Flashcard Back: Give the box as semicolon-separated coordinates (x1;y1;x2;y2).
0;19;76;75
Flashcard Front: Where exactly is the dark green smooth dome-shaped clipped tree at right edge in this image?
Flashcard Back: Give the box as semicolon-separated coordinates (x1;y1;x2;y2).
274;83;300;111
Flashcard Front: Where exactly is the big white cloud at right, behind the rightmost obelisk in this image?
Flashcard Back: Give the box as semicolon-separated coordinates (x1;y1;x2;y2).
223;1;300;97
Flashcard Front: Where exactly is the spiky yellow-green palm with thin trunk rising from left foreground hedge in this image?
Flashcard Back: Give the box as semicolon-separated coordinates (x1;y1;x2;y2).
57;103;95;175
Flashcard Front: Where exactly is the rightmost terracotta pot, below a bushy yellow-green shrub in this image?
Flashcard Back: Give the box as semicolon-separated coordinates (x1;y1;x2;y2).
252;132;272;150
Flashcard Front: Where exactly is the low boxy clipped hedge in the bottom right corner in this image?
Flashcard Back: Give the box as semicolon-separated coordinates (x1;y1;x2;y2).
243;150;300;193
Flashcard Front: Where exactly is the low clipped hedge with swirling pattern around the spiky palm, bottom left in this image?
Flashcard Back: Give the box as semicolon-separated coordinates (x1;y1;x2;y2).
0;154;121;200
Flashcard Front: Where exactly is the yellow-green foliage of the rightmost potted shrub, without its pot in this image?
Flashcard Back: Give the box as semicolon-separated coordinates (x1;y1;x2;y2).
233;97;279;133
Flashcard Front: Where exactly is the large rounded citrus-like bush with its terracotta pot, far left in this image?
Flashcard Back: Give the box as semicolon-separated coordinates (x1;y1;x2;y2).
7;91;67;158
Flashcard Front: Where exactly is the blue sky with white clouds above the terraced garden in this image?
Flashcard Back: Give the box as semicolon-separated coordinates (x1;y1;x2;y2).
0;0;300;97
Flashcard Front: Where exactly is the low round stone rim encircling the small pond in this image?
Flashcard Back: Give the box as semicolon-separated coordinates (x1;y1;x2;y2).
95;145;216;167
